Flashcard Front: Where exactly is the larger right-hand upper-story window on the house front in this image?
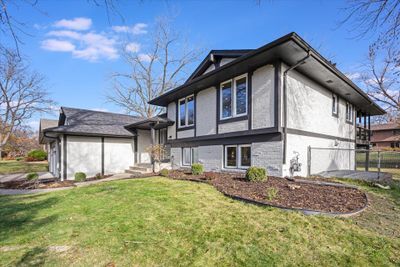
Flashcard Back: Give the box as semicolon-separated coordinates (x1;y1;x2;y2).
220;74;247;119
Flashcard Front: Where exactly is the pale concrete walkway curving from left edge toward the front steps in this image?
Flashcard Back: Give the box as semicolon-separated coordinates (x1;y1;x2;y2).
0;173;134;195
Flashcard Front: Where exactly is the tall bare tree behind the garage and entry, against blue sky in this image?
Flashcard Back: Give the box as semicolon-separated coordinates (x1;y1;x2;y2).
107;19;202;118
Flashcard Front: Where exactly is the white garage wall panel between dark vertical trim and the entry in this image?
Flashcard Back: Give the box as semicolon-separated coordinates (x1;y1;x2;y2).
104;138;134;174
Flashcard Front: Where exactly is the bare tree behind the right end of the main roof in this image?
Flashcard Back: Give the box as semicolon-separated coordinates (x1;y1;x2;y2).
361;45;400;121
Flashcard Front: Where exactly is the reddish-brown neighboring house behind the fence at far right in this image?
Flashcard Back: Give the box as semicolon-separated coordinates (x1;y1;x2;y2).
371;122;400;148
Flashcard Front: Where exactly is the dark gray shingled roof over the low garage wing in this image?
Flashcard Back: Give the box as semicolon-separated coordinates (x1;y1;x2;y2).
44;107;144;137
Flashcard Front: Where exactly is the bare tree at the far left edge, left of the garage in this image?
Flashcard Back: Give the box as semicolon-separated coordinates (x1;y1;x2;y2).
0;49;54;159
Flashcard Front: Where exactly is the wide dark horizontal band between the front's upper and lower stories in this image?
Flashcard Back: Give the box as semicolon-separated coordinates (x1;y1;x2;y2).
170;132;282;147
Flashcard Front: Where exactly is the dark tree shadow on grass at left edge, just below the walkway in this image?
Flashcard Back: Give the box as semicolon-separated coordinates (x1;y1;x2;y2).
0;195;58;244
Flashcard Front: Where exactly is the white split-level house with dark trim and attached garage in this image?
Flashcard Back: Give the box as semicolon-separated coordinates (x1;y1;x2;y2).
39;33;385;181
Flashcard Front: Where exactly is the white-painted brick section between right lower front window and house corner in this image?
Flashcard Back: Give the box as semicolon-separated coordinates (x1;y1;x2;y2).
251;141;283;176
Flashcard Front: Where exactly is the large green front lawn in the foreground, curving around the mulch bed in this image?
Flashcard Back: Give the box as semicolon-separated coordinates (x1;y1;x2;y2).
0;177;400;266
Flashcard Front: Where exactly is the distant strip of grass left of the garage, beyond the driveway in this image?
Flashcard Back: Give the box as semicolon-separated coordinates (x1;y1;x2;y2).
0;160;49;174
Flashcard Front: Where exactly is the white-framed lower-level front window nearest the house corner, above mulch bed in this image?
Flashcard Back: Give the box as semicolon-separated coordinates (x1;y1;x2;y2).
225;145;251;169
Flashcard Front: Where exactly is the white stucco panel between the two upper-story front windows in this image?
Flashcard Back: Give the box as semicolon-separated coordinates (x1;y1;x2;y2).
196;87;217;136
